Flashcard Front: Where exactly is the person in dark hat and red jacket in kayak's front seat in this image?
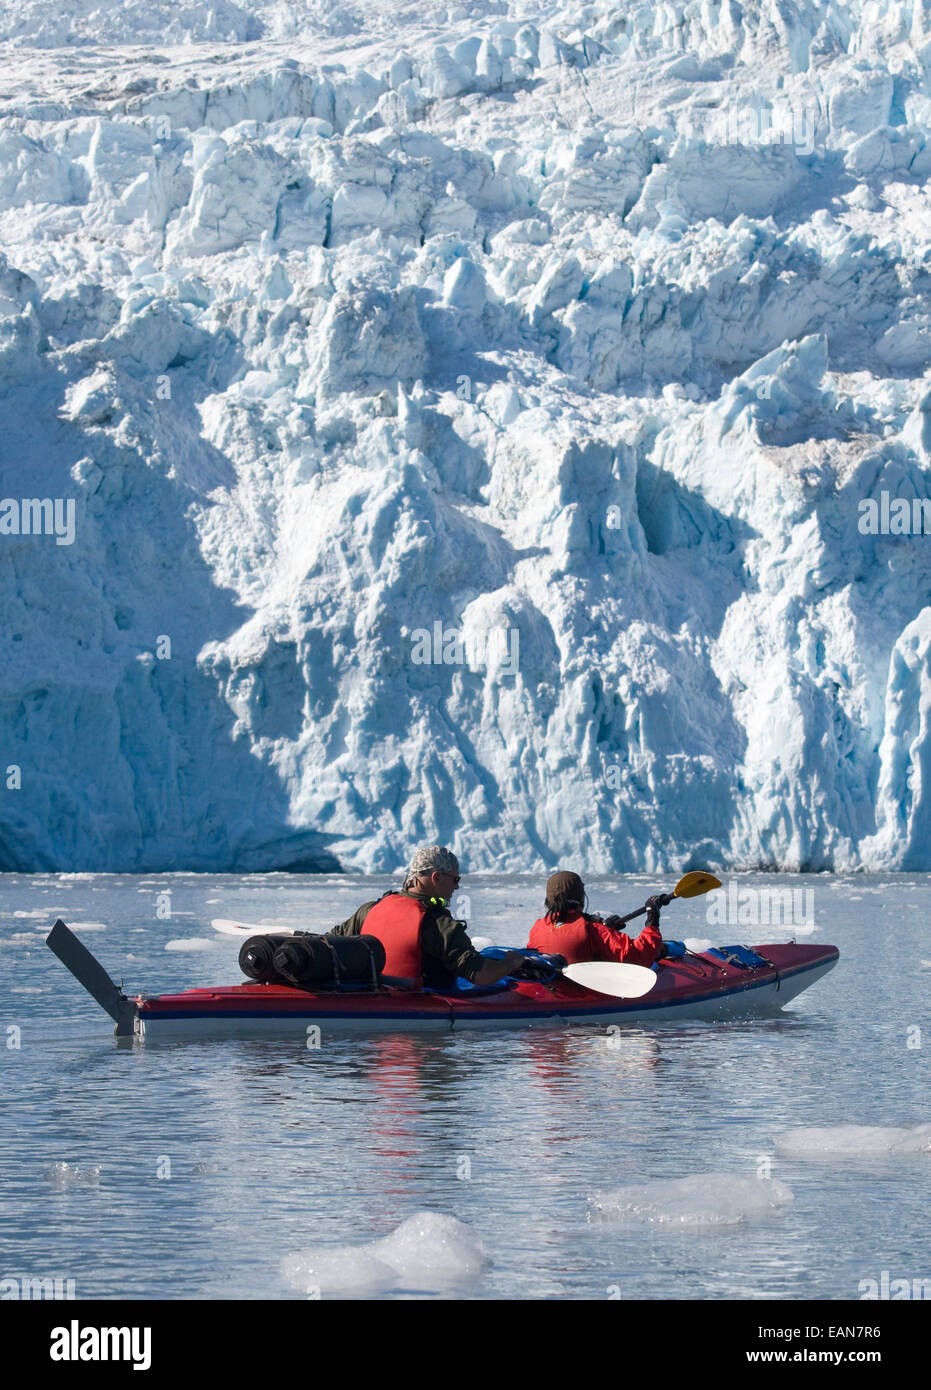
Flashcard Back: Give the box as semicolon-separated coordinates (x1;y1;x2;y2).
527;870;668;966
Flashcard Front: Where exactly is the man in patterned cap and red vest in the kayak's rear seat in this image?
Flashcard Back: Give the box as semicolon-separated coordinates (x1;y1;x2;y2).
332;845;524;990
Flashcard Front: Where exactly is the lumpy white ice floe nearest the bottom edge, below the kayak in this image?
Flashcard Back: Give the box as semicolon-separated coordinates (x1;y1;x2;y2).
281;1212;489;1293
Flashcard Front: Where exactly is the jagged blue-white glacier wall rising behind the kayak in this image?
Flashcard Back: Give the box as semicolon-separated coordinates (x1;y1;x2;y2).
0;0;931;872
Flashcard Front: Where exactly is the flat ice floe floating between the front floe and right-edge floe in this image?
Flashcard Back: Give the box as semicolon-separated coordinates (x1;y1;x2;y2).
588;1173;795;1227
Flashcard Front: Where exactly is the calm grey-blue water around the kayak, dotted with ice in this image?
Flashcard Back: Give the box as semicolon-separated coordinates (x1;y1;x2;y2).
0;874;931;1298
